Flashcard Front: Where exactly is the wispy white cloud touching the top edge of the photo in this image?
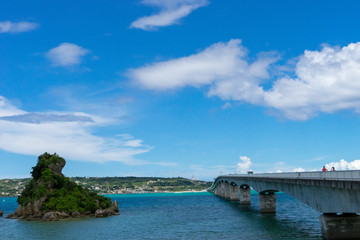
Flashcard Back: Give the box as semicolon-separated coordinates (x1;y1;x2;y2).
130;0;208;31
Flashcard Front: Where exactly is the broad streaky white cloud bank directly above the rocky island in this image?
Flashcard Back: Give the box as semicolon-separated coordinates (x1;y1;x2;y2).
0;97;152;165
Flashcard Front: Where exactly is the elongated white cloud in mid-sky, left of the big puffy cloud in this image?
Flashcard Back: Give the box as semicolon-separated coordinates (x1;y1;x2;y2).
128;39;276;102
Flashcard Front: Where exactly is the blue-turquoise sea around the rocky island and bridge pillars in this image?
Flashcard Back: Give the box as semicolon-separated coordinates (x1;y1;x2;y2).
0;192;321;240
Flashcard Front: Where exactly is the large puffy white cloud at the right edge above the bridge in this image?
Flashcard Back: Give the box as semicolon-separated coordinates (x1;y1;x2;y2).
264;42;360;120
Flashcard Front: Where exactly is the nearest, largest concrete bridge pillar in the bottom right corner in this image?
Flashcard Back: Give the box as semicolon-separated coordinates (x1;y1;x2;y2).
319;213;360;240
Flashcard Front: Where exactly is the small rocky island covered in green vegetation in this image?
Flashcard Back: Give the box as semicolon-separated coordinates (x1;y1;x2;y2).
7;153;119;221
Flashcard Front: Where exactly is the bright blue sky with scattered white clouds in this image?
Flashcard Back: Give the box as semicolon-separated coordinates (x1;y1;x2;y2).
0;0;360;180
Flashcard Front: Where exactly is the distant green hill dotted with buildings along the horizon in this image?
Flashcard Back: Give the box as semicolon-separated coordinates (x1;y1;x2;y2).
0;177;212;197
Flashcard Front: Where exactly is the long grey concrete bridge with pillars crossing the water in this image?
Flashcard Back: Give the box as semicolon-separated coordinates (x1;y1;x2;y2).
209;170;360;239
